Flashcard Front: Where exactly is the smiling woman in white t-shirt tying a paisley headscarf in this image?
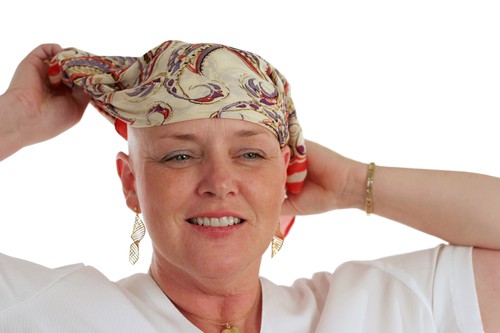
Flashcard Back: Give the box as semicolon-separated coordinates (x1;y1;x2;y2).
0;42;500;333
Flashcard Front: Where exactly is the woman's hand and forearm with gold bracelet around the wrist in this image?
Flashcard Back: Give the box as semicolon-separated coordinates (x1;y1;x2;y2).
283;142;500;250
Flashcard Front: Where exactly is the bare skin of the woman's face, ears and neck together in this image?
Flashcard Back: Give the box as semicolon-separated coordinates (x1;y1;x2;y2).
117;119;289;332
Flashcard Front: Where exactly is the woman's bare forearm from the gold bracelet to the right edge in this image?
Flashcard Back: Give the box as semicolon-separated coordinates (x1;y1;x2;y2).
360;167;500;249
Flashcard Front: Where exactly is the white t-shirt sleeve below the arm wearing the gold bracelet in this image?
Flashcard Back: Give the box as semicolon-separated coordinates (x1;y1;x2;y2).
340;245;483;333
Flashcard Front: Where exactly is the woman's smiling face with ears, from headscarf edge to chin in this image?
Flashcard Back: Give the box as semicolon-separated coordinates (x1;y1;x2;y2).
118;119;289;278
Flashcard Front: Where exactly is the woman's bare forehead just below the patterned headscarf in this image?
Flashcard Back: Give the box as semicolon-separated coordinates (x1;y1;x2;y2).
129;119;279;144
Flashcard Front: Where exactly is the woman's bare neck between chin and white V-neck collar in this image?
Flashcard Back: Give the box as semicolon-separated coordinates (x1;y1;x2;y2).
149;255;261;333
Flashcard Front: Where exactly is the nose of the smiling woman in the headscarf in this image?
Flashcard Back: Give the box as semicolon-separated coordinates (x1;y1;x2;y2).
198;157;238;198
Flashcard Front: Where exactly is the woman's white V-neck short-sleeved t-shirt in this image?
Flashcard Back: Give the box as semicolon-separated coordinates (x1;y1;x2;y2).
0;246;483;333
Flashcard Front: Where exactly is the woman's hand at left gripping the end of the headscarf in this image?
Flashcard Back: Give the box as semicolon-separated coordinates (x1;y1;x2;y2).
0;44;89;160
